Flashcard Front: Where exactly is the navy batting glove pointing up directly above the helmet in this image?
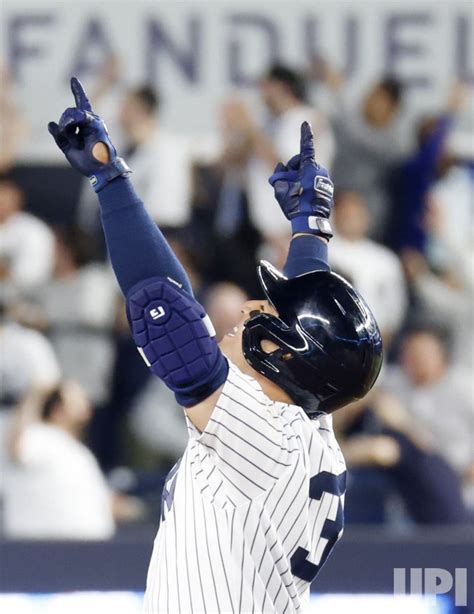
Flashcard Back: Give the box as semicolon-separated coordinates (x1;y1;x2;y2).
268;122;334;239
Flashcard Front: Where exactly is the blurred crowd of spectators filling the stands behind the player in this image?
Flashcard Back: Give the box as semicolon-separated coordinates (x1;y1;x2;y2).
0;58;474;539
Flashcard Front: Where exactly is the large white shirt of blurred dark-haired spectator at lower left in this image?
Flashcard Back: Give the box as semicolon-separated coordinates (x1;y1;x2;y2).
4;423;115;540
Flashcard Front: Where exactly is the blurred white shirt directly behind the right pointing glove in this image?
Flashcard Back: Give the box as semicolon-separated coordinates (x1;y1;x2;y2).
247;105;335;236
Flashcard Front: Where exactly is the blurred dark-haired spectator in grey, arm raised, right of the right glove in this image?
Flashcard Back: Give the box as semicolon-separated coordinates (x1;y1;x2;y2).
316;60;403;239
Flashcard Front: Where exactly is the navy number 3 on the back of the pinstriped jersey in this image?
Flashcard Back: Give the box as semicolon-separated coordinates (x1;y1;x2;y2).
291;471;346;582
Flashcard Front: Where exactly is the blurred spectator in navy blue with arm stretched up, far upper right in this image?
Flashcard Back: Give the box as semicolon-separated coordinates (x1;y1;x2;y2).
387;84;465;252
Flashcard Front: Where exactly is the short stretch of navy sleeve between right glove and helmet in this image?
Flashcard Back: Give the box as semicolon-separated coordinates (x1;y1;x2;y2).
283;235;330;278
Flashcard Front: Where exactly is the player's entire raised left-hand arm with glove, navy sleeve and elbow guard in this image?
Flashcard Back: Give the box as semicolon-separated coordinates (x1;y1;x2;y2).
48;77;228;414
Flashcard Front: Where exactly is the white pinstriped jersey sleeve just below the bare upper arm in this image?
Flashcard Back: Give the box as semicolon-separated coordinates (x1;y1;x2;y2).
193;365;296;504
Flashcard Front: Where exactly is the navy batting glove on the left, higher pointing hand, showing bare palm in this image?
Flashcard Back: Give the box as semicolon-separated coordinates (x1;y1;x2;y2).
48;77;132;192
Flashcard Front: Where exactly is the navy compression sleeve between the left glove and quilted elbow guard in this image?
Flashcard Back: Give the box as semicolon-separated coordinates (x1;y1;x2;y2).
99;177;192;296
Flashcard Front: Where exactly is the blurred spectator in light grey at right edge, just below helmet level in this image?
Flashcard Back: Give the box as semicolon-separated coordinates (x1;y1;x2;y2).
383;326;474;506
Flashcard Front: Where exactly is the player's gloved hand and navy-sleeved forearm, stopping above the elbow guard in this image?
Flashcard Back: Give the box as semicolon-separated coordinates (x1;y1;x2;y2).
48;77;192;296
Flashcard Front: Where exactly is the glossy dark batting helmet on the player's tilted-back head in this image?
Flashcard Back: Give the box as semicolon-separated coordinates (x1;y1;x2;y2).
242;261;382;416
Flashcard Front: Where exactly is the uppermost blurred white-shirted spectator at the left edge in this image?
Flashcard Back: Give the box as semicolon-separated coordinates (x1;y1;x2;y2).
0;176;54;293
